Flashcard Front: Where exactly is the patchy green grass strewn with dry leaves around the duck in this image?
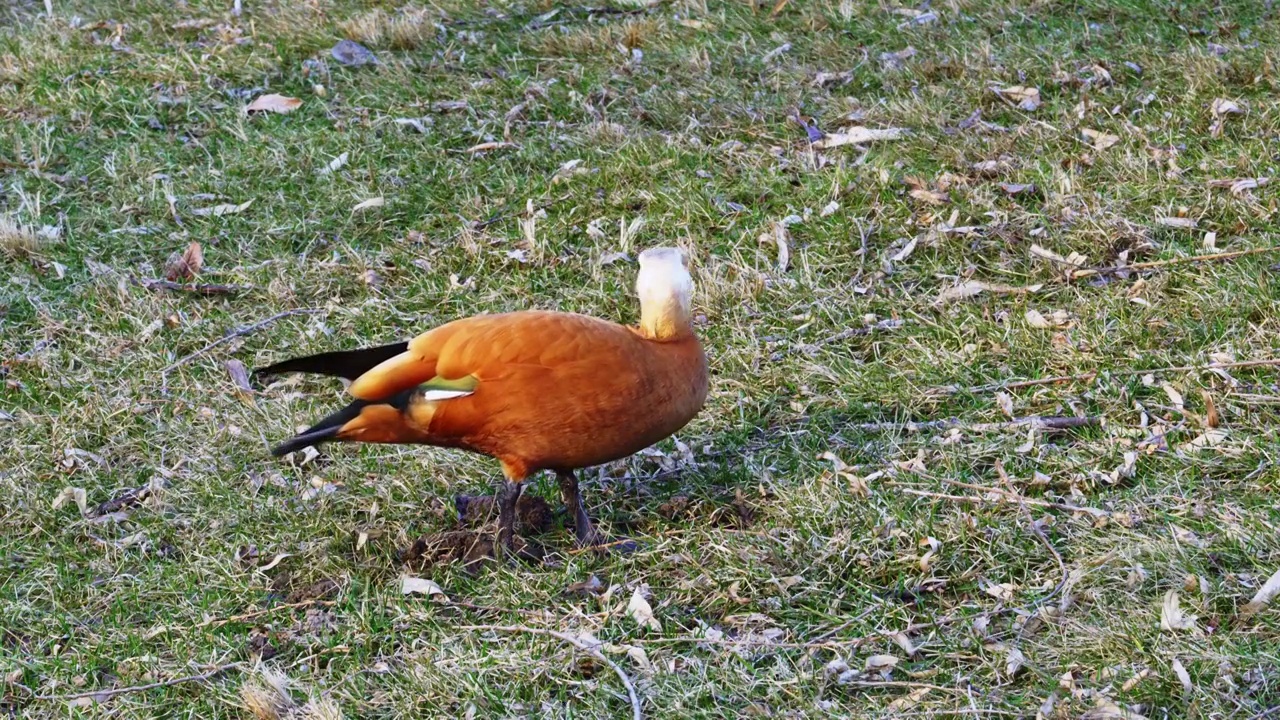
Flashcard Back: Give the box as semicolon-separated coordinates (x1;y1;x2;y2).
0;0;1280;717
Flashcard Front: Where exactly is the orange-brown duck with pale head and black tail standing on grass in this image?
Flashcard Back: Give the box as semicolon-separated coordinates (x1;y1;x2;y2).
253;247;709;553
